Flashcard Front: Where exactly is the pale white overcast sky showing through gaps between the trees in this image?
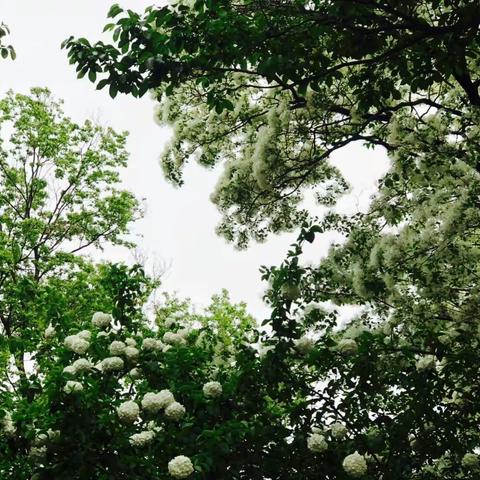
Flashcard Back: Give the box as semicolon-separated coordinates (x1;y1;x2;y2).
0;0;388;320
